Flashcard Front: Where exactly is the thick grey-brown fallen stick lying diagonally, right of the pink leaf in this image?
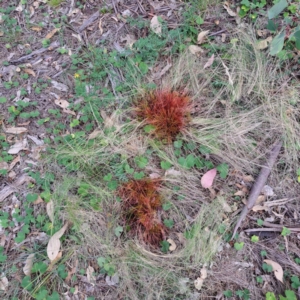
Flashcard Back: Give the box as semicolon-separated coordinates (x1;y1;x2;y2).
231;141;282;239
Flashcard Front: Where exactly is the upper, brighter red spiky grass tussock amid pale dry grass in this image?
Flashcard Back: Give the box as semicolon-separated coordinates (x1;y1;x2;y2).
136;90;190;143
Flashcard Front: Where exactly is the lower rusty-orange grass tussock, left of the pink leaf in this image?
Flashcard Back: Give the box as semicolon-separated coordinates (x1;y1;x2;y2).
118;179;166;246
